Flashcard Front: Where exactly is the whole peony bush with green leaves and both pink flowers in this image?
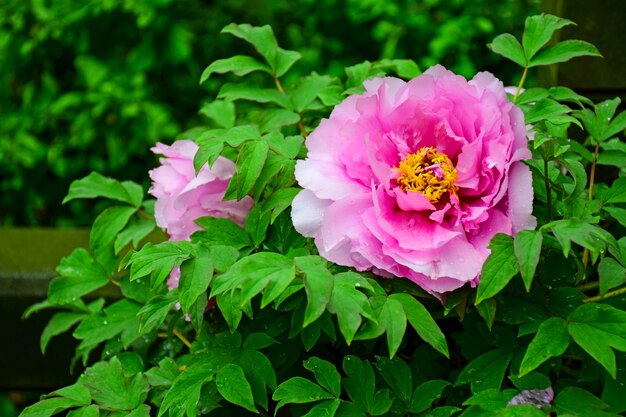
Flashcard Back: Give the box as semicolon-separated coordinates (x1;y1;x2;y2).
21;11;626;417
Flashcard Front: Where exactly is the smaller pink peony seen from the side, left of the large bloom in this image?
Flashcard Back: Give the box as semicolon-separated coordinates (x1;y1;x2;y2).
149;140;254;240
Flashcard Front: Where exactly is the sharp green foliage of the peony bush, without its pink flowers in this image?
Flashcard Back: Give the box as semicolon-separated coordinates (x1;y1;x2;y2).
22;8;626;417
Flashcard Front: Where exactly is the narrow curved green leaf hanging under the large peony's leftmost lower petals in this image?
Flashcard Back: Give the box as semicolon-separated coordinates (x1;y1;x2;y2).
294;256;334;327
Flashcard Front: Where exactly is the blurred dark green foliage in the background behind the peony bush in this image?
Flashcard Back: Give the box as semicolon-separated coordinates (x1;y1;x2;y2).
0;0;540;226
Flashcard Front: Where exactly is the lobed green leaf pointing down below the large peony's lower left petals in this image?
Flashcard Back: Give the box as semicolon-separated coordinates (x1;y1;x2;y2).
328;272;376;345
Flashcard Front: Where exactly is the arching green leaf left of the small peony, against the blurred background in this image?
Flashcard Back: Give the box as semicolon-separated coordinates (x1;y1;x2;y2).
63;172;137;207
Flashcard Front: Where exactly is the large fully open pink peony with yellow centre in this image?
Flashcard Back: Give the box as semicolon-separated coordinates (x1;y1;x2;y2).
292;66;536;295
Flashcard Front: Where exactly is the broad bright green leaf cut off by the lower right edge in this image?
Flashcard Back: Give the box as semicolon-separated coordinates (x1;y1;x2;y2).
567;303;626;378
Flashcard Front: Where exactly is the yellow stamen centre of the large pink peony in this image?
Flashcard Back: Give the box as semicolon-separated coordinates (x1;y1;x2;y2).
393;147;458;203
